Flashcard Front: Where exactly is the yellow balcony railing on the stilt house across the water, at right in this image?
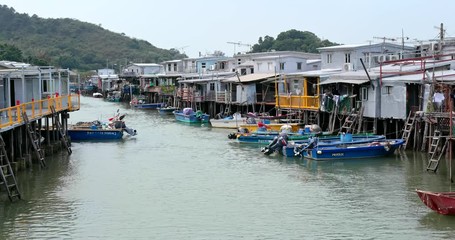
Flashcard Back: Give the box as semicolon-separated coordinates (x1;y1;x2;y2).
275;95;319;110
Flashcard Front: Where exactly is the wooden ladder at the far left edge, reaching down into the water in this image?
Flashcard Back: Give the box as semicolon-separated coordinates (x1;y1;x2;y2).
0;135;21;202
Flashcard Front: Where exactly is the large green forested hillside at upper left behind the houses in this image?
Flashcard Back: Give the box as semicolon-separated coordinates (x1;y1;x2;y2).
0;5;186;70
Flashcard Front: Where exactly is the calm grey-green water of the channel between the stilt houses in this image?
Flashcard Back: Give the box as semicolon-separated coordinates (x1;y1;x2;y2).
0;98;455;239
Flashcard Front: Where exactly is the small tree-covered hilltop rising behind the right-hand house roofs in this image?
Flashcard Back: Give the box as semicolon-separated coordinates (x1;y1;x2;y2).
252;29;338;53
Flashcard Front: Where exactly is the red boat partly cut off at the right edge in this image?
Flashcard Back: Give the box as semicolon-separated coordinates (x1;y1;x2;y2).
416;189;455;215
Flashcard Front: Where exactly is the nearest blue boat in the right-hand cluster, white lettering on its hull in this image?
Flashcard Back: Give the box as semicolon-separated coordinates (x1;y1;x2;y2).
299;139;404;160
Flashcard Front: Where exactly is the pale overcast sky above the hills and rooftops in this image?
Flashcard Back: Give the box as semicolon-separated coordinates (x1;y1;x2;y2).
0;0;455;57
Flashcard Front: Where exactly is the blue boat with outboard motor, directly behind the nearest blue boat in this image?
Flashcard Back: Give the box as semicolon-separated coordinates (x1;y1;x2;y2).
281;133;385;157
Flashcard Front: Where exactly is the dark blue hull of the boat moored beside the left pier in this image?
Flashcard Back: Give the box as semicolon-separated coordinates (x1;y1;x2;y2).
68;129;123;141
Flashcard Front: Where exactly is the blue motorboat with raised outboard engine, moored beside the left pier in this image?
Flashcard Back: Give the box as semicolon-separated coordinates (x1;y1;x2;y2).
68;111;137;141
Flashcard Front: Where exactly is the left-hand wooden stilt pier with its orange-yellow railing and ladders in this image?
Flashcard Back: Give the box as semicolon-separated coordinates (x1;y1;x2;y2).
0;94;80;201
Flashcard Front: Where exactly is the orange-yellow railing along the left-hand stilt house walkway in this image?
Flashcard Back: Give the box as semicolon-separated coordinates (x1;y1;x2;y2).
0;94;81;129
